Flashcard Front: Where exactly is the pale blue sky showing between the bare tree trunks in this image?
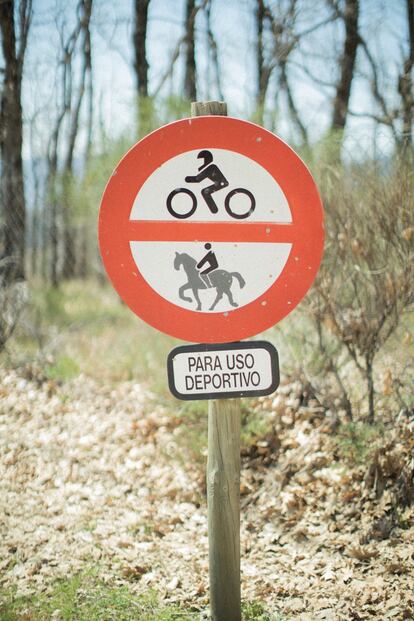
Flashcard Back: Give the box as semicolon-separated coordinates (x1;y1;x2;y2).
18;0;406;161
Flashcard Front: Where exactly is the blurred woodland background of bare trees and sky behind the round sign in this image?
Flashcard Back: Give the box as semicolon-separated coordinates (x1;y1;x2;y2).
0;0;414;616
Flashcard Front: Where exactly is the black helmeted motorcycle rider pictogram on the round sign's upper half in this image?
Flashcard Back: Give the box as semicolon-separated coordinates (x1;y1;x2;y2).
167;150;256;220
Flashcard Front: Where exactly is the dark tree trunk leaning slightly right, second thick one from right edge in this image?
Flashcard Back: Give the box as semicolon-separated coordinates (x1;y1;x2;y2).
331;0;359;131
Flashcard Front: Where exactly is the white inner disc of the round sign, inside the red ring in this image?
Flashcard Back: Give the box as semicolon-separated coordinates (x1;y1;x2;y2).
130;149;292;313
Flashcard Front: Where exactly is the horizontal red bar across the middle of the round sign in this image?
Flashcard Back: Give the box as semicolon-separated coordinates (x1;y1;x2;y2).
127;220;303;244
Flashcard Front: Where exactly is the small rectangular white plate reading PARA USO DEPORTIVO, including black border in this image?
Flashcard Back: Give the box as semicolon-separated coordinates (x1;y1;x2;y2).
168;341;279;400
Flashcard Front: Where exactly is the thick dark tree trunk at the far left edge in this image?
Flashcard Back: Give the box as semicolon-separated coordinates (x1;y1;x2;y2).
0;0;30;284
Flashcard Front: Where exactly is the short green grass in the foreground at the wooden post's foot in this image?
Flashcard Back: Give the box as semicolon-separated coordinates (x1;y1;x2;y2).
0;570;285;621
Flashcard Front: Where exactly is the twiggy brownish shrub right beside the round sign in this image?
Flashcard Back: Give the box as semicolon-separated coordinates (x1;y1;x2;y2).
292;152;414;423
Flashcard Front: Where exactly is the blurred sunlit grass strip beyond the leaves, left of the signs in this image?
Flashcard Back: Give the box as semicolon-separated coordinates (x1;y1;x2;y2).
0;281;177;388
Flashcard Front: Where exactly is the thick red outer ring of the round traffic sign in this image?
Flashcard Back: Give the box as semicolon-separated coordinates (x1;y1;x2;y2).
99;116;324;343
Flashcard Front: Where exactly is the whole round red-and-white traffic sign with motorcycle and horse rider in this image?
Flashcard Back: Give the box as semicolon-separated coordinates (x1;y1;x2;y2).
99;116;323;343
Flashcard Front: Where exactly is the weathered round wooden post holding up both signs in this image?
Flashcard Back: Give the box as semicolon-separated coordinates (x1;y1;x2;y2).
191;101;241;621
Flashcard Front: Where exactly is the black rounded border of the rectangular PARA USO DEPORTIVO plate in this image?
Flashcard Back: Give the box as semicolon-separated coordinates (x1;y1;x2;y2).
167;341;280;401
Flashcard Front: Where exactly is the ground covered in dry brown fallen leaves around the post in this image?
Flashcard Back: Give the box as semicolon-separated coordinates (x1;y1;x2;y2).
0;368;414;621
